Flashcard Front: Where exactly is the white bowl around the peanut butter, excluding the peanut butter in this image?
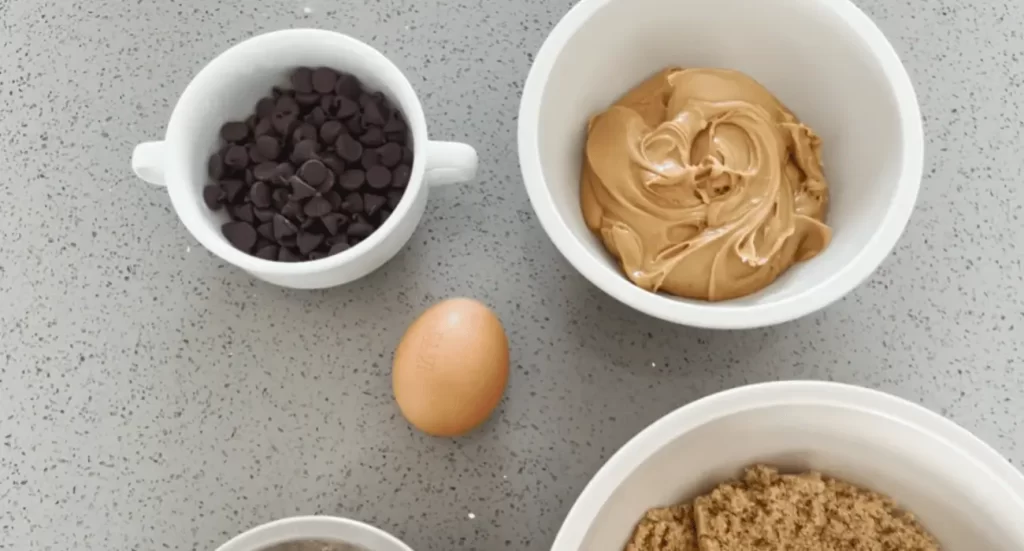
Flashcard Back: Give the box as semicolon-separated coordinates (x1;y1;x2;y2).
519;0;924;329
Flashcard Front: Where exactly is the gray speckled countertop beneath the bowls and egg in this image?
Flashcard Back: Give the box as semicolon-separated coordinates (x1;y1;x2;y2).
0;0;1024;551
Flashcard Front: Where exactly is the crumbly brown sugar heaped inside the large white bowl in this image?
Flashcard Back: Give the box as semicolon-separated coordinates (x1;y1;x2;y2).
626;465;939;551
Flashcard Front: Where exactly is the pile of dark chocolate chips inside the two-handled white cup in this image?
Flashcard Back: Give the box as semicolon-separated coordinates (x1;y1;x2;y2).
203;68;413;262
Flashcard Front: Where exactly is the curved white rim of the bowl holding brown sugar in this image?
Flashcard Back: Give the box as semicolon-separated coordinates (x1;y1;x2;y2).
551;381;1024;551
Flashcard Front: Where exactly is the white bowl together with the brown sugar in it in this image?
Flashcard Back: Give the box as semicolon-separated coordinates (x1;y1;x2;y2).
552;381;1024;551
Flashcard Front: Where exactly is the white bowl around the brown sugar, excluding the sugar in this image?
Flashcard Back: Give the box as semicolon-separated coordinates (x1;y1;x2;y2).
552;381;1024;551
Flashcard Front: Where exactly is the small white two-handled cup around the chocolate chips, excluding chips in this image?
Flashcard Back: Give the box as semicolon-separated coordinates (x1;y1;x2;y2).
132;29;477;289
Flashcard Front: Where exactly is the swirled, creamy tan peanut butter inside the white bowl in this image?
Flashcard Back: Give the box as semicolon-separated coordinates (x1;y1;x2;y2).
581;69;831;300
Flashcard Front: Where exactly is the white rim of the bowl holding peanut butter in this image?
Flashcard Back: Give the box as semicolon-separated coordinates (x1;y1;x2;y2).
518;0;925;329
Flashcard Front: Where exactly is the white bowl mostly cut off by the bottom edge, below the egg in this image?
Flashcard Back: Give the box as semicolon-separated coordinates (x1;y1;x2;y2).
217;516;413;551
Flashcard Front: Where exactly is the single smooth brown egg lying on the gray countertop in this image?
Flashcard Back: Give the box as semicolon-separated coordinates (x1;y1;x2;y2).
391;298;509;436
